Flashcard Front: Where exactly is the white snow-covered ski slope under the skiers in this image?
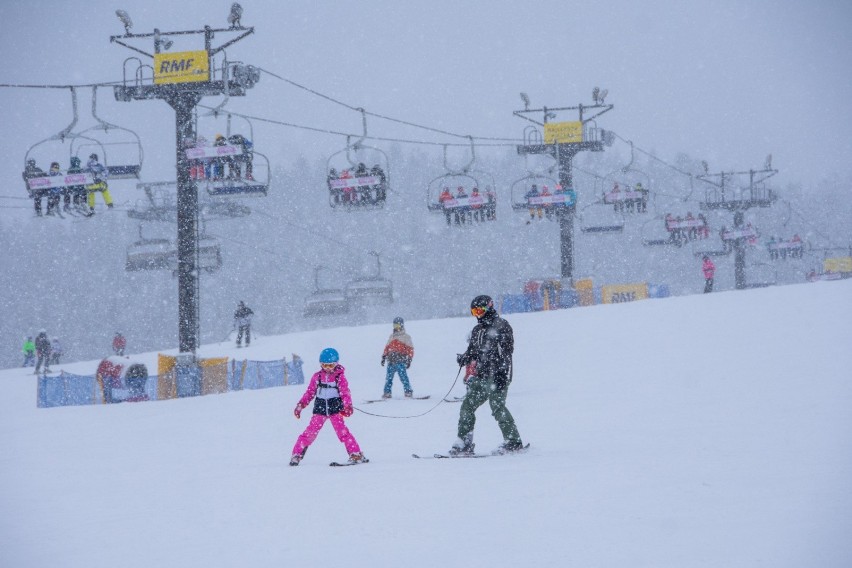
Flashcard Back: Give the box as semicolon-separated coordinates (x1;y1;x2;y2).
0;281;852;568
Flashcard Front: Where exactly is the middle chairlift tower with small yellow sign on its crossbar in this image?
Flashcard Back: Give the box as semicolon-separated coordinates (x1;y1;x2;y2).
512;92;613;279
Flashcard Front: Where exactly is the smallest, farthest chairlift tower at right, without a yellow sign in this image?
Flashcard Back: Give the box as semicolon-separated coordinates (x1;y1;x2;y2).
696;162;778;290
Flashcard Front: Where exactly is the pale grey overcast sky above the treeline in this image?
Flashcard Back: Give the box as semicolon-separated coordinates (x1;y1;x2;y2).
0;0;852;191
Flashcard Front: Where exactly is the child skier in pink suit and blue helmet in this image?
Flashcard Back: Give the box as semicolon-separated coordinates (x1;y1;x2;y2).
290;347;369;466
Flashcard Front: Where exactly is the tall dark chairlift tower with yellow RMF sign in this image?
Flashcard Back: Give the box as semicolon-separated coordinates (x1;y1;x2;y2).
110;3;260;365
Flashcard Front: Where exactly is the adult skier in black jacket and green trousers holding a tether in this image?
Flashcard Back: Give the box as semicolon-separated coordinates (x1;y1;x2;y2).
450;295;524;456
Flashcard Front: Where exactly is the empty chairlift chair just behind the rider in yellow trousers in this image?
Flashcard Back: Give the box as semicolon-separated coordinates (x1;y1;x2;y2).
71;86;144;179
